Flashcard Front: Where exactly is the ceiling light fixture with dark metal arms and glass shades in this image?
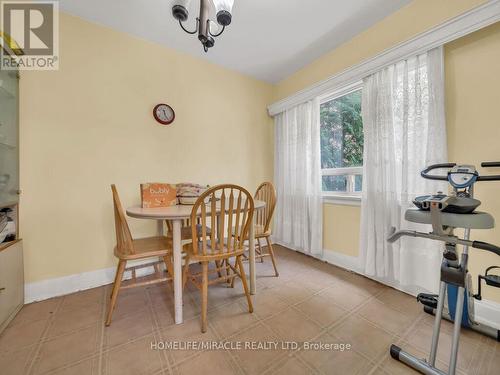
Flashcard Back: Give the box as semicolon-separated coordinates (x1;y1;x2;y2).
172;0;234;52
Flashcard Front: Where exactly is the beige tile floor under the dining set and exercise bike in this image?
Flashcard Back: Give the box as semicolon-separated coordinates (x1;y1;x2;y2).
0;246;500;375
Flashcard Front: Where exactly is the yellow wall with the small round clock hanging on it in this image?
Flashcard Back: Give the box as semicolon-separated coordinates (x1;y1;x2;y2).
20;14;273;283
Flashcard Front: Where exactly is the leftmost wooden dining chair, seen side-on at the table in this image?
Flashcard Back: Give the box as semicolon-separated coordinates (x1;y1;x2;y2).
106;185;173;326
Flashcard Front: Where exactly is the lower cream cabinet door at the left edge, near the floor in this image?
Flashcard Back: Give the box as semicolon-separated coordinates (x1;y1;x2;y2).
0;241;24;332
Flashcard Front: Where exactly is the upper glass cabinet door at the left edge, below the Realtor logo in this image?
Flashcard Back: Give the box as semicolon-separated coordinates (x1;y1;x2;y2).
0;70;19;206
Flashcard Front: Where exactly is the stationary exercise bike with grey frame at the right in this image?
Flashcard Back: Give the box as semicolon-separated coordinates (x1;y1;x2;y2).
387;162;500;375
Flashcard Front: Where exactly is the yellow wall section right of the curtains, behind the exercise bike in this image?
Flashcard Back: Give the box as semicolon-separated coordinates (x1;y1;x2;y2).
445;23;500;301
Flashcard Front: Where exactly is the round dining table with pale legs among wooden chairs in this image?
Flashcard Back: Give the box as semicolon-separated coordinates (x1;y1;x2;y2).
127;200;266;324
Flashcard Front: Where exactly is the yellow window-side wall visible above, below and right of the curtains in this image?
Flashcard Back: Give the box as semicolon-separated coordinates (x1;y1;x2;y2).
274;0;500;301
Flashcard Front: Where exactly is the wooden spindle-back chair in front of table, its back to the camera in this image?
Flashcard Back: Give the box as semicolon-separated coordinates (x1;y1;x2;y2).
183;185;254;332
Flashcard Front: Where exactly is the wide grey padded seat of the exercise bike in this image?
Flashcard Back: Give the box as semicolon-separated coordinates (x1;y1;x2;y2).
405;208;495;229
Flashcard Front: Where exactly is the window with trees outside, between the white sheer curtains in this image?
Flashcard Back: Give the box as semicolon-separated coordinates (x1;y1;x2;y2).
320;86;363;201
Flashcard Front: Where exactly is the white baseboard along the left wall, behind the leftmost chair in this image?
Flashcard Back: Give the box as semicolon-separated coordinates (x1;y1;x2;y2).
24;259;160;303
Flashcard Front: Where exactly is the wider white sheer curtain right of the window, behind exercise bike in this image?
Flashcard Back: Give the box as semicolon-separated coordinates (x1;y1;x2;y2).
360;47;447;293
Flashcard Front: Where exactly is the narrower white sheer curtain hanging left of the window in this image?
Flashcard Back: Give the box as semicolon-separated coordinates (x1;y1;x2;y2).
273;100;323;256
